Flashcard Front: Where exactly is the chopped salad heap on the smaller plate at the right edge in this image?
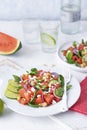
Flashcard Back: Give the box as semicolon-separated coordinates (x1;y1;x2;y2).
62;39;87;68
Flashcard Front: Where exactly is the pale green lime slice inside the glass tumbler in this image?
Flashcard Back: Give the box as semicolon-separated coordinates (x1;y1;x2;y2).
41;33;56;46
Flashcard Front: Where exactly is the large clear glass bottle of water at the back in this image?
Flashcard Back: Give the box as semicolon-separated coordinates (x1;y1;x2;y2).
60;0;81;34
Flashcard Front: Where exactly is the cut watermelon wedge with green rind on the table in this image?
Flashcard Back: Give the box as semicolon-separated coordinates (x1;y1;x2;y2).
0;32;22;55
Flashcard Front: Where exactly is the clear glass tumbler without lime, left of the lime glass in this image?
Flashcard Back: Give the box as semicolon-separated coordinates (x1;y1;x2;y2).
23;19;40;45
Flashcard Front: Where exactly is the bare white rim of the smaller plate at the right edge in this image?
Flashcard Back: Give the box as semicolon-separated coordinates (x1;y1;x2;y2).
58;41;87;72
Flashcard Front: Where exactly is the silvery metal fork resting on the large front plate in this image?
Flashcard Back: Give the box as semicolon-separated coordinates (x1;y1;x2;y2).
62;71;71;112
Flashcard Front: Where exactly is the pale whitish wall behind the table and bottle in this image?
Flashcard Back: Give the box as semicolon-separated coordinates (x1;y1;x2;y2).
0;0;87;20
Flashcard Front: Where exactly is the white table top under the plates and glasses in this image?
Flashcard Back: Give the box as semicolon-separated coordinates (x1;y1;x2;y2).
0;21;87;130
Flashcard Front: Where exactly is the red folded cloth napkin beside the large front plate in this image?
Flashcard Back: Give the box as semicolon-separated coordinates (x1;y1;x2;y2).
70;77;87;114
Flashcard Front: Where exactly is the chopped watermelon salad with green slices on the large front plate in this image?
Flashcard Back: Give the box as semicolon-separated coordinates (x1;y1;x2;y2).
5;68;72;107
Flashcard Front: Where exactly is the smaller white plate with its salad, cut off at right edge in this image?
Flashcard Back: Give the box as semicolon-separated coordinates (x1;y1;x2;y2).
58;39;87;72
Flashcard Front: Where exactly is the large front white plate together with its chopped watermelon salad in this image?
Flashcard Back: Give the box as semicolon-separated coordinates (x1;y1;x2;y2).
0;66;80;117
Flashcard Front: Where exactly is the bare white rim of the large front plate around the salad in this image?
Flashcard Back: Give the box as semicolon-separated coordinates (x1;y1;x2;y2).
0;65;80;117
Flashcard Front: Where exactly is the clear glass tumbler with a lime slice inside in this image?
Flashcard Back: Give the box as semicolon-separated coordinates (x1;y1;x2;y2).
40;21;58;53
